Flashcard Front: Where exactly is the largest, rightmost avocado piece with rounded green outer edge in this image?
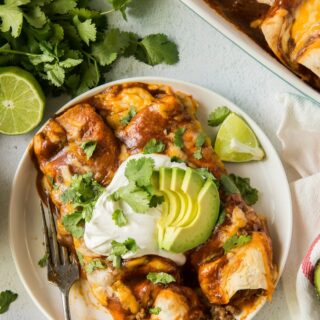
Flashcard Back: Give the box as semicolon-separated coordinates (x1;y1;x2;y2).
160;179;220;253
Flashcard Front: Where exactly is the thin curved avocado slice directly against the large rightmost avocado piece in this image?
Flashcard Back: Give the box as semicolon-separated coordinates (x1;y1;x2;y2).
171;168;204;227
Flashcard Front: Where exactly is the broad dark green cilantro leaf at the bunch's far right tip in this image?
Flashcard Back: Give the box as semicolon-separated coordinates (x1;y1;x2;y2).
135;34;179;66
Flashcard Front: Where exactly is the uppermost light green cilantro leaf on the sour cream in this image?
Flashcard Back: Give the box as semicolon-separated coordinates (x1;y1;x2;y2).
124;157;154;187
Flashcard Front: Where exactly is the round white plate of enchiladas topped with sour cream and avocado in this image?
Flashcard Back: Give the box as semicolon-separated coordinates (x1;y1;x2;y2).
10;79;291;320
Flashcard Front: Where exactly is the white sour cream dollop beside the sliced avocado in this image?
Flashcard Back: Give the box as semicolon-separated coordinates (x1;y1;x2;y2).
84;154;186;265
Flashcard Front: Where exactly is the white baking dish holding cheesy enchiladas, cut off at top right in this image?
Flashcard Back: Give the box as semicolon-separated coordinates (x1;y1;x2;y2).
181;0;320;102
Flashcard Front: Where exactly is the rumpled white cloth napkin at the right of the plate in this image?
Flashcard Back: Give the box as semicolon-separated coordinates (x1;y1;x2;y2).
277;94;320;320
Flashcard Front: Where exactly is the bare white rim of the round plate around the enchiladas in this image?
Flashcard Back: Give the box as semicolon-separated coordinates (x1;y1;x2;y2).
9;77;292;319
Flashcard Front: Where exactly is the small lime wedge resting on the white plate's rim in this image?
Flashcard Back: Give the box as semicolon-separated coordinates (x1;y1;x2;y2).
214;113;265;162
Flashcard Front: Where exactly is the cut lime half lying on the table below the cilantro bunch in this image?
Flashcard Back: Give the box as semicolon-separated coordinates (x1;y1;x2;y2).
0;67;45;135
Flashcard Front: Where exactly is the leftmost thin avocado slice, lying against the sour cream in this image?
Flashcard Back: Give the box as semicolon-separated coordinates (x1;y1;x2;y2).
158;167;181;241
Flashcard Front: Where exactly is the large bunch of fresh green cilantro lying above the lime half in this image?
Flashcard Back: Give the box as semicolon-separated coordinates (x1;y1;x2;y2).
0;0;179;95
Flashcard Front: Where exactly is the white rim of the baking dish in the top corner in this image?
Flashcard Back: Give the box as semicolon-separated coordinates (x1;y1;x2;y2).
181;0;320;102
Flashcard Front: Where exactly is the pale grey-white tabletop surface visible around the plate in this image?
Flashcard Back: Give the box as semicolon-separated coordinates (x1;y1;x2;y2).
0;0;295;320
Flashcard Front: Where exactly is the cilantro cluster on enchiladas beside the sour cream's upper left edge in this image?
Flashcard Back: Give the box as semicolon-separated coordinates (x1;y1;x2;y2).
60;173;104;222
